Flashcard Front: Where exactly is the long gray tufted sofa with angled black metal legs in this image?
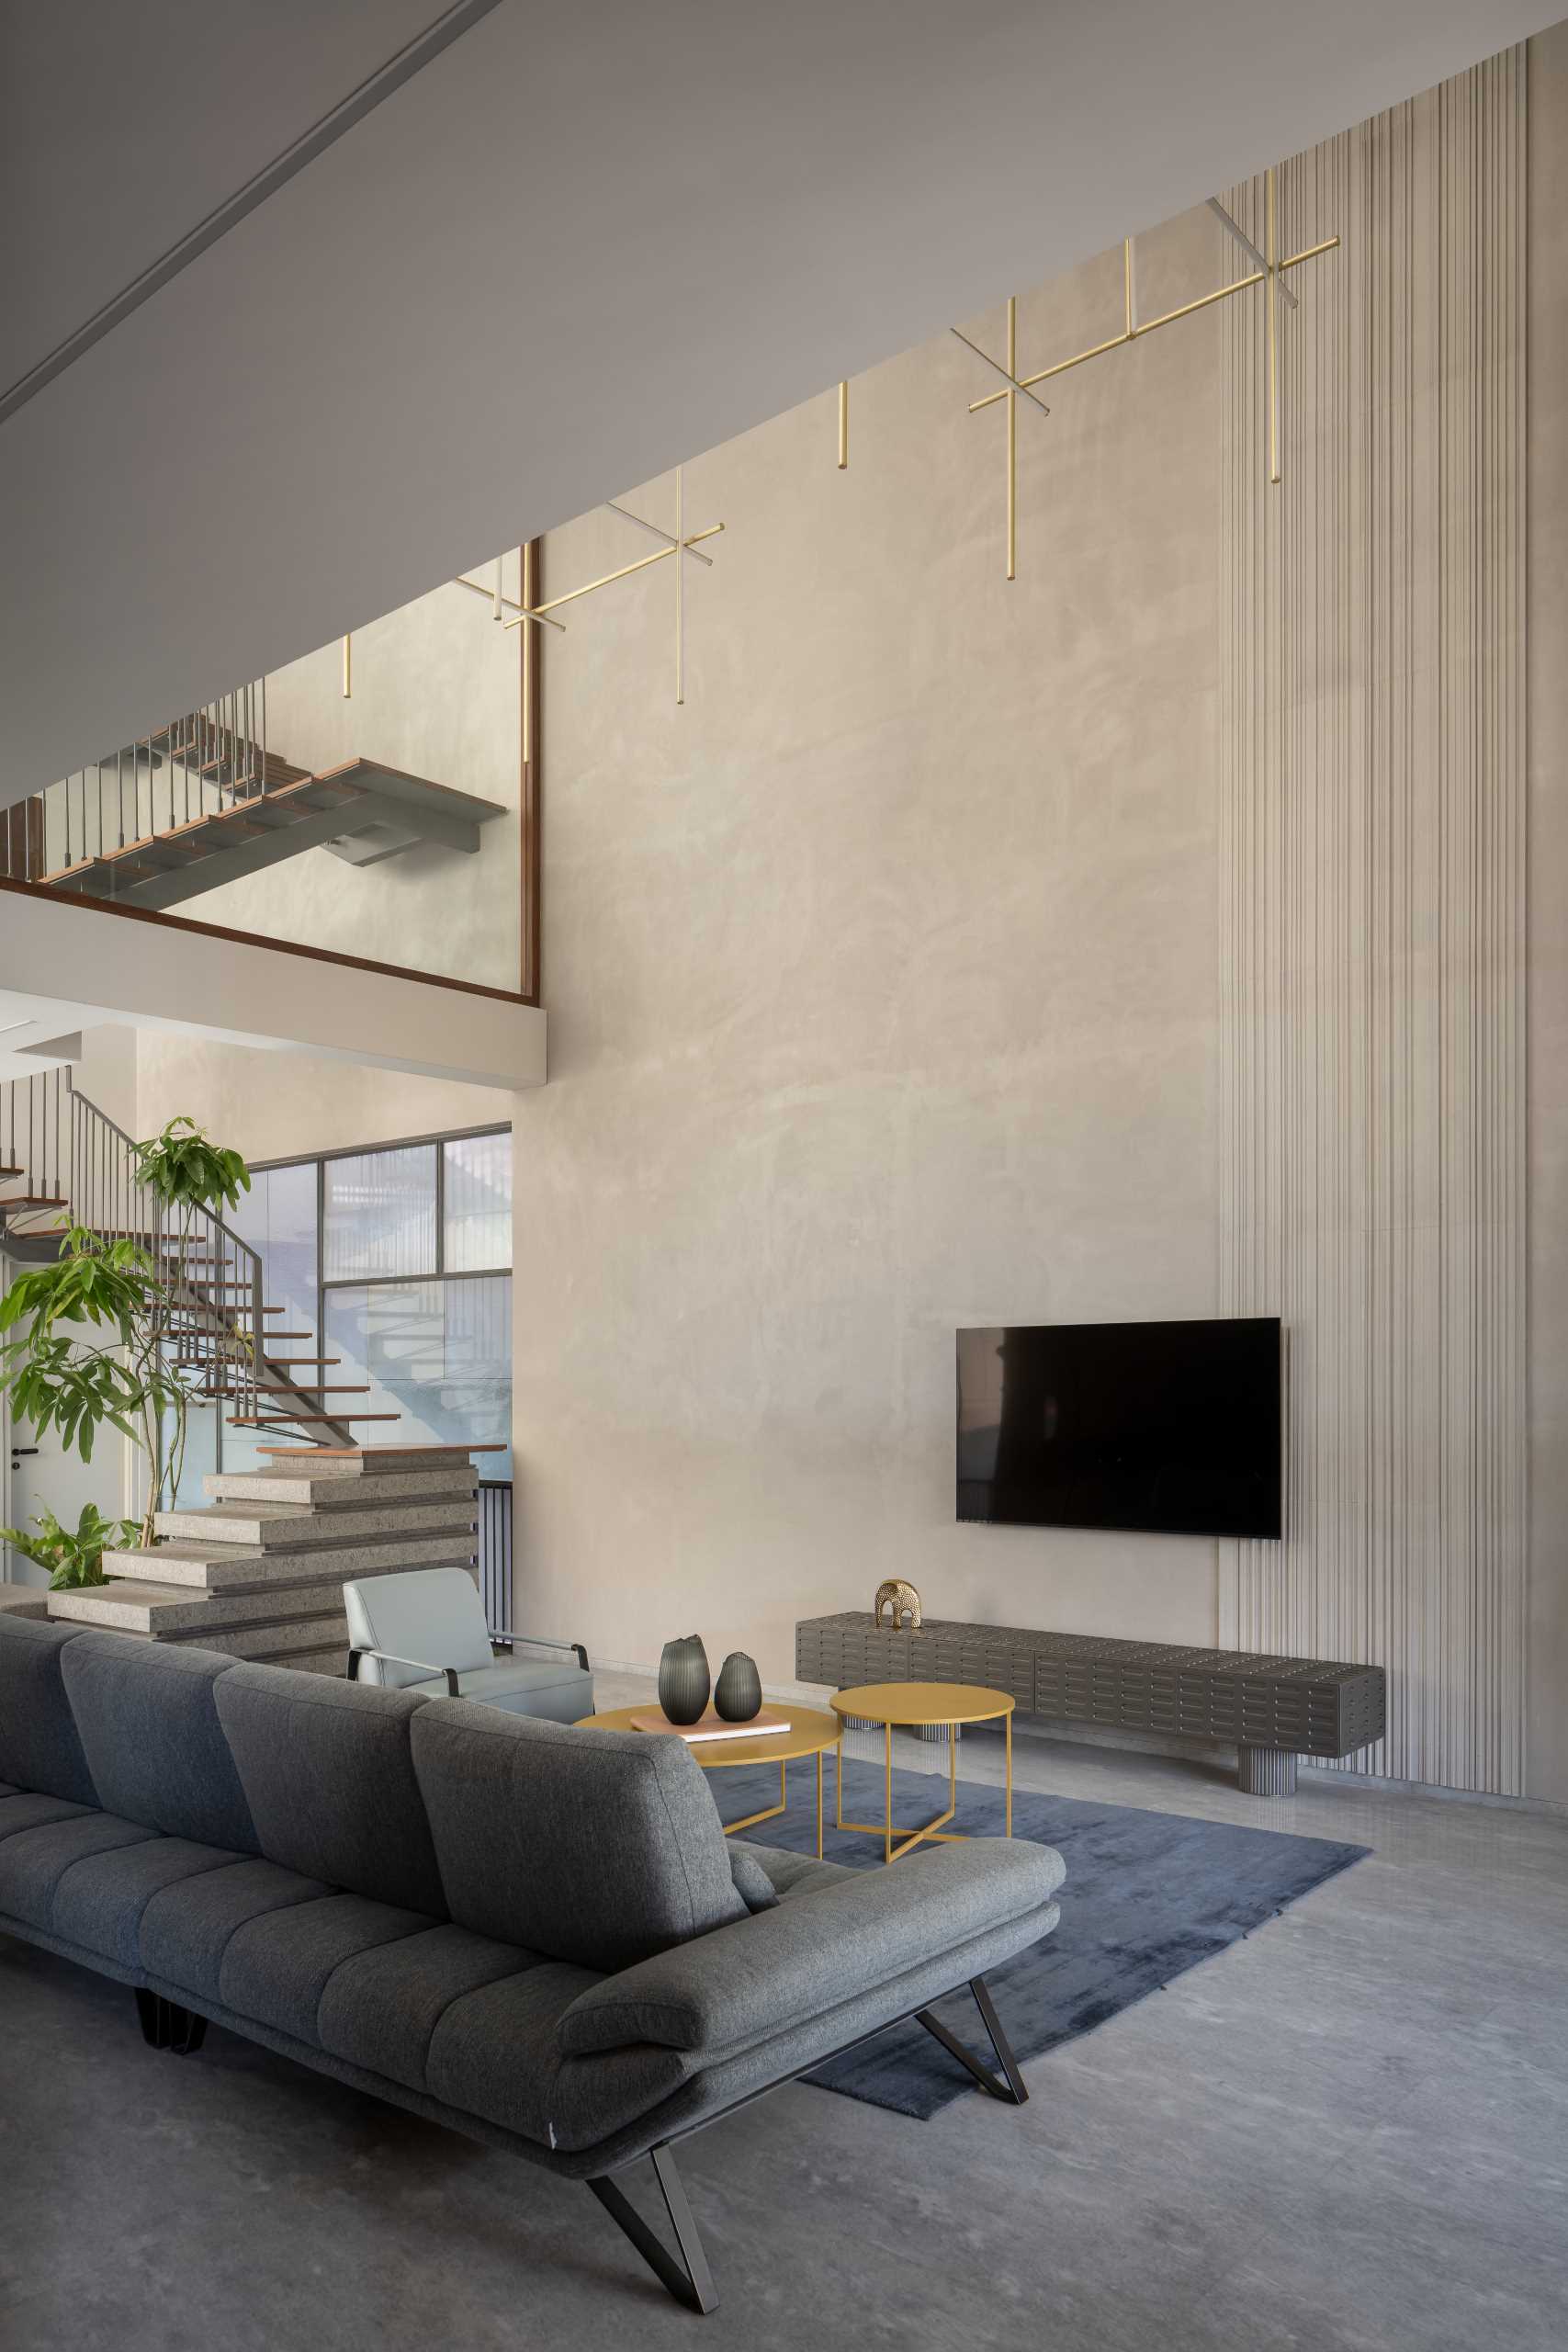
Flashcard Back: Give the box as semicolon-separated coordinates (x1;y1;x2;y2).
0;1618;1063;2310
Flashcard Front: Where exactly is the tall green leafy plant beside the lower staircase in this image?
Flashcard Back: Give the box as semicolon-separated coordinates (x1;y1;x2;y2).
0;1117;249;1583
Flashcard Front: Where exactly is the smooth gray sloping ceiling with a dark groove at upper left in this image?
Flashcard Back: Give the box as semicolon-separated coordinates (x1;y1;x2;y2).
0;0;1554;802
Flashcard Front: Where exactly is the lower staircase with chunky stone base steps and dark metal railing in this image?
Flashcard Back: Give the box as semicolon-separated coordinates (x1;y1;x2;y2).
0;1070;491;1675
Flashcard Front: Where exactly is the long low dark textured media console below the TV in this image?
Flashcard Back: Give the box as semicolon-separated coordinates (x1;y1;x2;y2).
795;1609;1387;1797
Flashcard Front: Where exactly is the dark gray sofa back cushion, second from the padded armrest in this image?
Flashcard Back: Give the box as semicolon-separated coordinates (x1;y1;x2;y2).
214;1665;446;1919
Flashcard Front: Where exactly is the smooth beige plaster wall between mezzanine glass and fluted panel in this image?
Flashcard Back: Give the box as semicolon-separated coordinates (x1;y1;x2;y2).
514;214;1223;1679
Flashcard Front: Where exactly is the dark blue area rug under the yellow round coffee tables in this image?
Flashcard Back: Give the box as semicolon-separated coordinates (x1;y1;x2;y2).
715;1734;1371;2120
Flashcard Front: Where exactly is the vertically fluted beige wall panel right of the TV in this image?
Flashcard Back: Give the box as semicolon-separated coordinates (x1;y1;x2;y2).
1220;50;1523;1794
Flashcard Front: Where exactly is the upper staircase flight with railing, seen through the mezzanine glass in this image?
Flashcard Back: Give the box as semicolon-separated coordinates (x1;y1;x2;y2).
0;680;505;910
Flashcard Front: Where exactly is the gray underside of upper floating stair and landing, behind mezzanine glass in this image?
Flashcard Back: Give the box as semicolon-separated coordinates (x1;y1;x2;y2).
42;760;505;908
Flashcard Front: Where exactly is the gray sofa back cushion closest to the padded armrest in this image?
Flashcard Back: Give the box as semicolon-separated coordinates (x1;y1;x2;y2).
412;1698;748;1969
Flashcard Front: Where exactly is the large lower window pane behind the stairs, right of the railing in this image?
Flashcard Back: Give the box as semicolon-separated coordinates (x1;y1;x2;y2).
327;1275;513;1479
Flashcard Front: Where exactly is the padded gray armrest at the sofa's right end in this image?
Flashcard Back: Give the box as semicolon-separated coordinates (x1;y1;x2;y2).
558;1837;1067;2058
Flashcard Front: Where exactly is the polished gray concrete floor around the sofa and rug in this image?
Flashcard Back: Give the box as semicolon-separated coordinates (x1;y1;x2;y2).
0;1681;1568;2352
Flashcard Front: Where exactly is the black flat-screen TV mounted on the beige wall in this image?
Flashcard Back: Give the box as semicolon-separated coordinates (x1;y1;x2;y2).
957;1315;1281;1536
